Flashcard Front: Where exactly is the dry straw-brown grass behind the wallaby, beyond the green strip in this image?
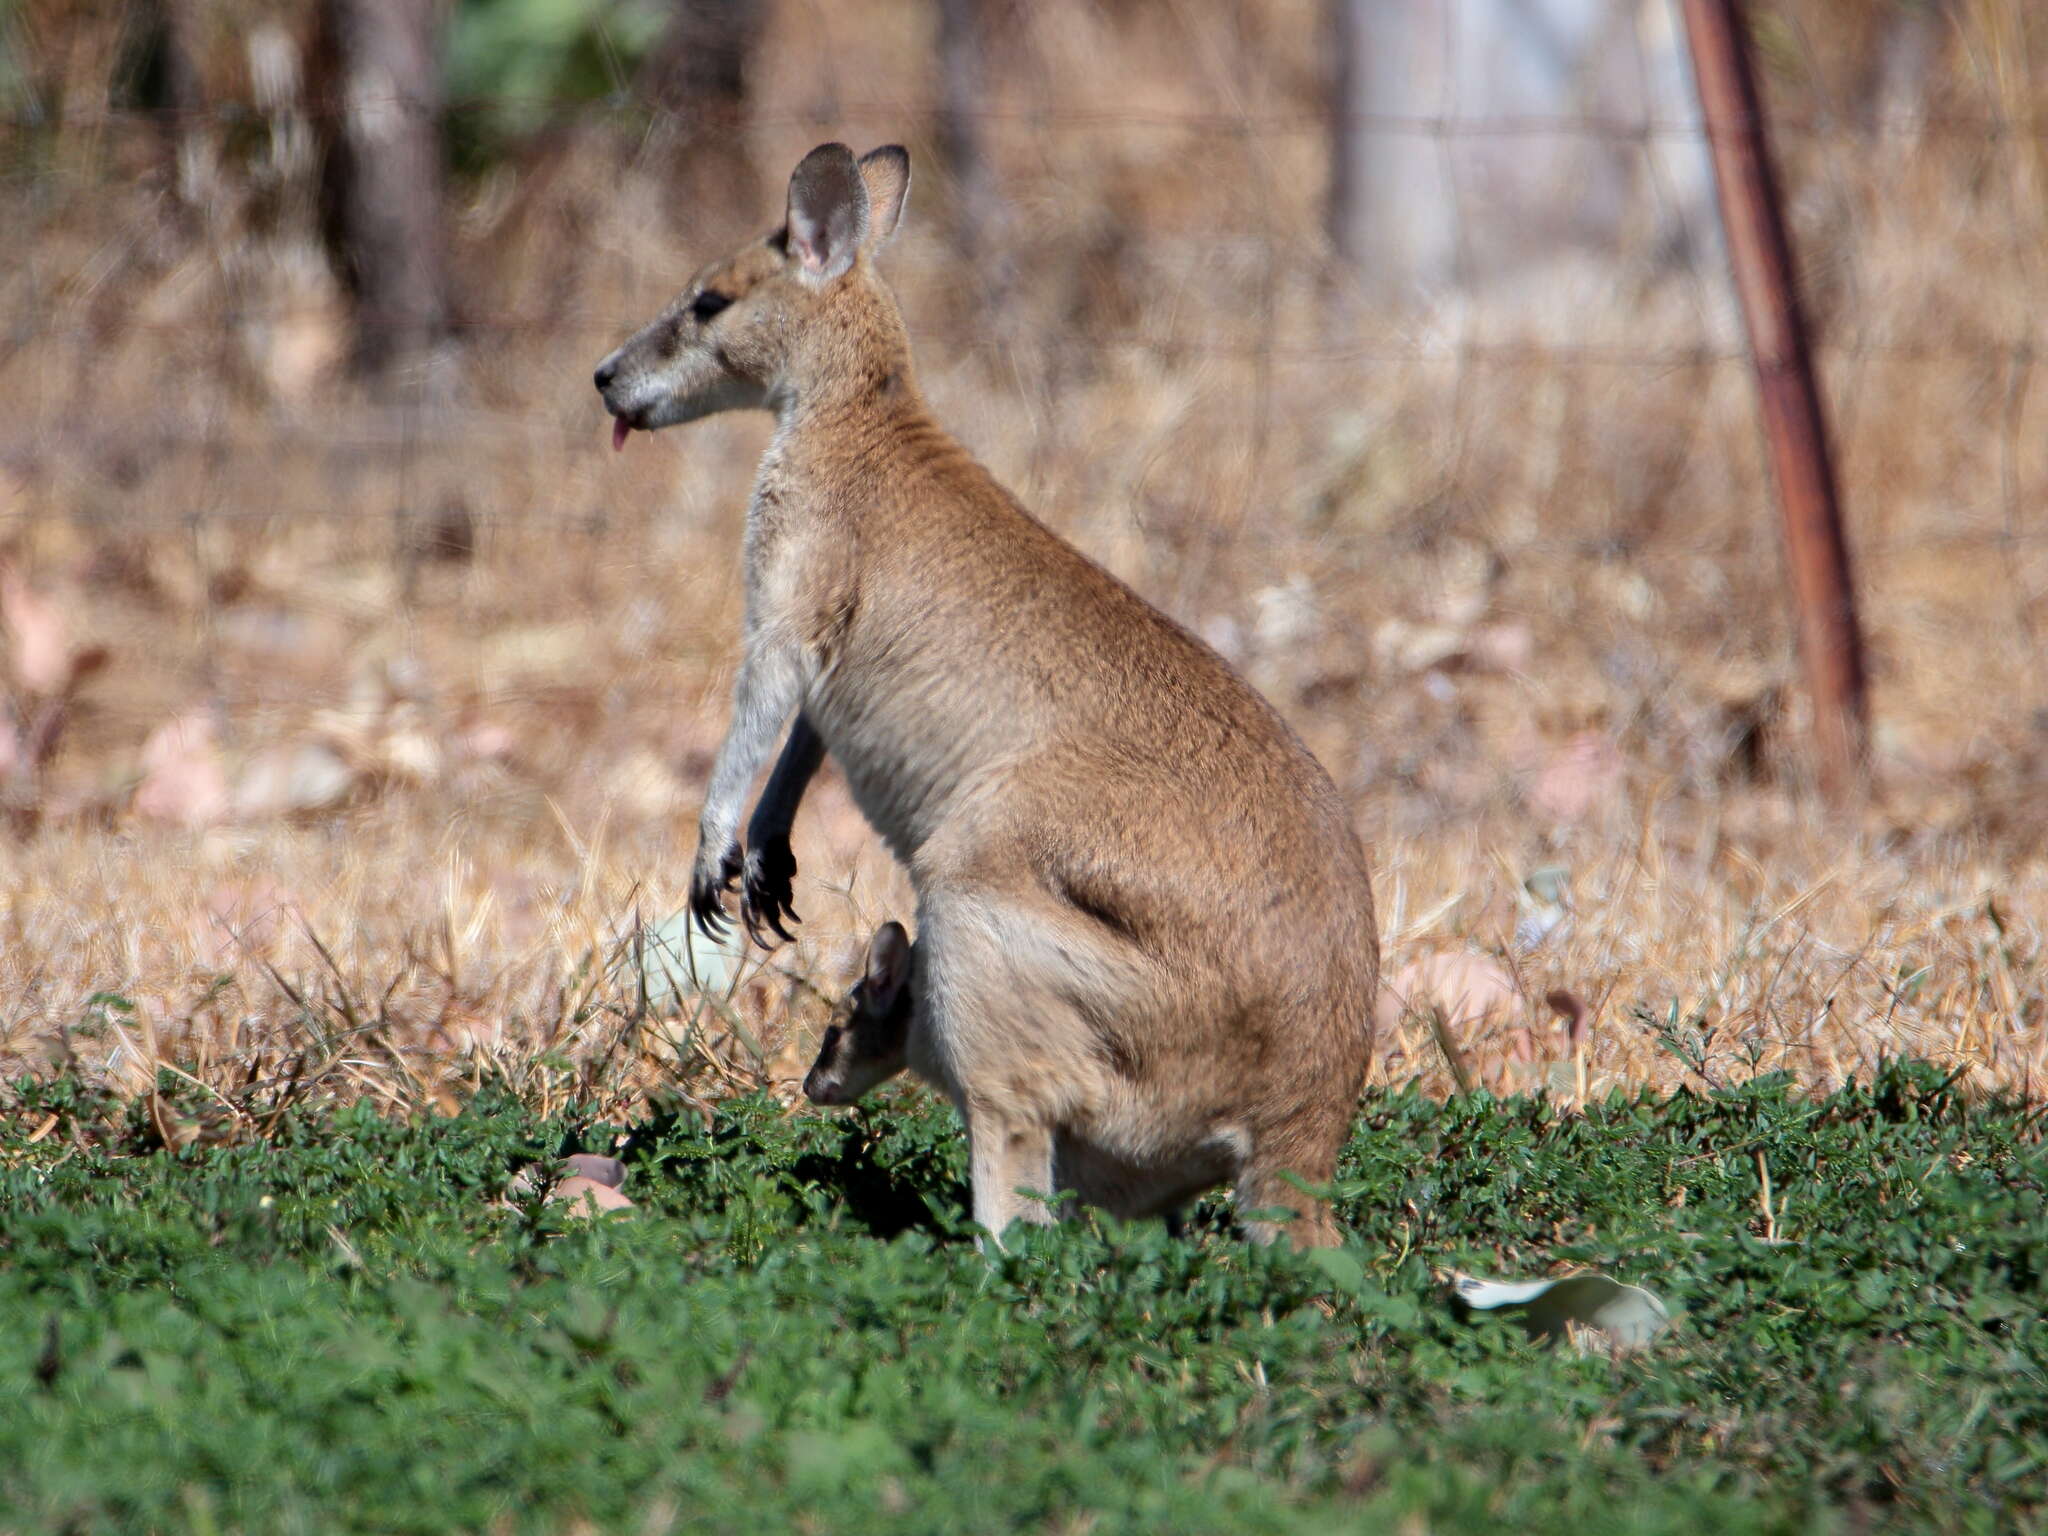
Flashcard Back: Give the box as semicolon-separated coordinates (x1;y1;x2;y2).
0;0;2048;1126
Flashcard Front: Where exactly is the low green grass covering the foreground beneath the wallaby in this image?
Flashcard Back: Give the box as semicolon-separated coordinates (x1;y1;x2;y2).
0;1069;2048;1536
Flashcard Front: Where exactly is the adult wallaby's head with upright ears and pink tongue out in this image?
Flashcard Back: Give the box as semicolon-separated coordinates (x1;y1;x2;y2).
596;143;909;449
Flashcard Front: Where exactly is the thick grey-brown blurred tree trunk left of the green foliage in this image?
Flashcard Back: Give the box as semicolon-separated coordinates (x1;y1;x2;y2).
313;0;449;377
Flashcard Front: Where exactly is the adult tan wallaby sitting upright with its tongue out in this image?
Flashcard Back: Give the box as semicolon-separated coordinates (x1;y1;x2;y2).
596;143;1378;1243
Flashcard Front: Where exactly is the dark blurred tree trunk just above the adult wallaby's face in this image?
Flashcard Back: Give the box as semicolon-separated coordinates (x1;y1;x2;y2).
641;0;766;229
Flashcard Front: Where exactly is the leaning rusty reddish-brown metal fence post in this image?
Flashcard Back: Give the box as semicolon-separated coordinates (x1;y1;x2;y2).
1686;0;1866;801
